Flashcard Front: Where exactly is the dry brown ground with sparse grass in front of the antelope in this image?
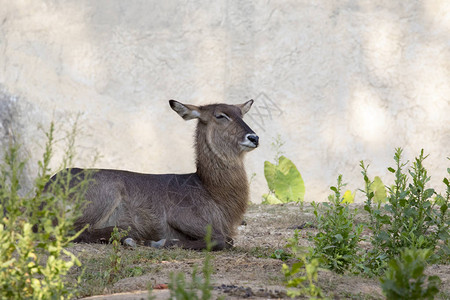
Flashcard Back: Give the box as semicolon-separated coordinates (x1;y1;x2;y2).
69;204;450;299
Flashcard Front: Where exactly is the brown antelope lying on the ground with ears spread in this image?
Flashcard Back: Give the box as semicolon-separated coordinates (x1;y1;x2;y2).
47;100;259;250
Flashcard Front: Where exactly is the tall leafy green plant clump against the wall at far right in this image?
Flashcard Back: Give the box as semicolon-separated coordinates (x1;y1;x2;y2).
361;148;450;271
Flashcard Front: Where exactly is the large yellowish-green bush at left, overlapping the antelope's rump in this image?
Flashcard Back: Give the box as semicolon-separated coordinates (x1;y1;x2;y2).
0;123;90;299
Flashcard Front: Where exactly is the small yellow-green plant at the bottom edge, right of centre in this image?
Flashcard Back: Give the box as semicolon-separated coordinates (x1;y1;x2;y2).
282;230;325;299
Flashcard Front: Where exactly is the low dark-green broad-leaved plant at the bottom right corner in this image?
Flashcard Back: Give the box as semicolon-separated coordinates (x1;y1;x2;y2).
380;249;441;300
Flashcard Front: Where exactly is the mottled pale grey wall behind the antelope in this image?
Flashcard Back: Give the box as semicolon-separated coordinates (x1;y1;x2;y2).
0;0;450;202
